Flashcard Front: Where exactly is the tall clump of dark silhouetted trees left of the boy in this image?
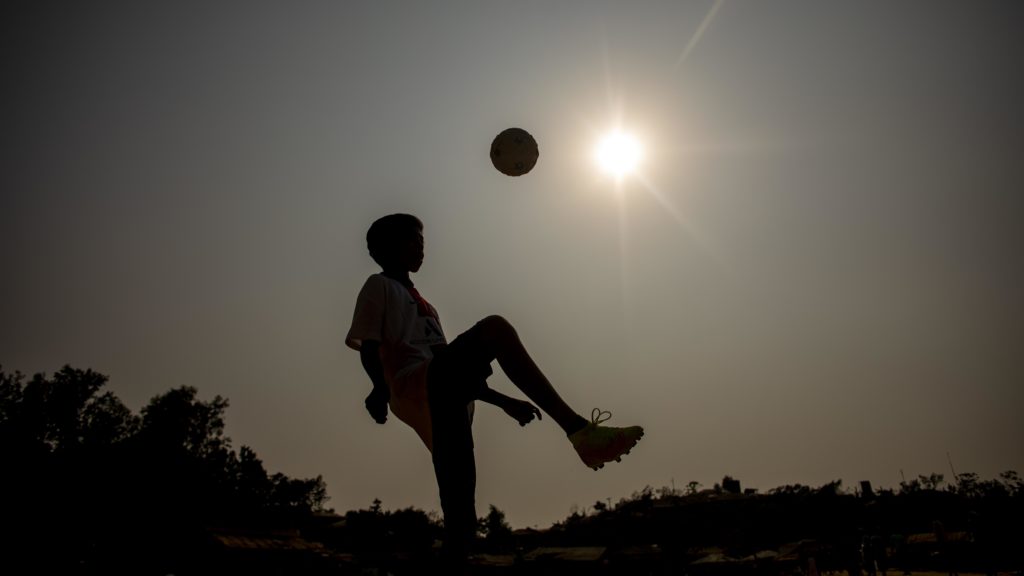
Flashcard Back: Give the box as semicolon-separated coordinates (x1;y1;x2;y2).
0;366;328;569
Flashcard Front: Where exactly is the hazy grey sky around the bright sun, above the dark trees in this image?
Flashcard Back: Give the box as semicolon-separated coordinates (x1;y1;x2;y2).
0;0;1024;528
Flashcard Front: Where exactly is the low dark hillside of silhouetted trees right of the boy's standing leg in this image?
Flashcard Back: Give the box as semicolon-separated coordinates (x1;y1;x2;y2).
547;470;1024;574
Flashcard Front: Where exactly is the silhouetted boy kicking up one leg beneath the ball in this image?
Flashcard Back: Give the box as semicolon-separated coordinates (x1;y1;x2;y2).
345;214;643;563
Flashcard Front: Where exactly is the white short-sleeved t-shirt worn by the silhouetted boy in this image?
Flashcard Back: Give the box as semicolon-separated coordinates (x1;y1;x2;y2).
345;274;446;449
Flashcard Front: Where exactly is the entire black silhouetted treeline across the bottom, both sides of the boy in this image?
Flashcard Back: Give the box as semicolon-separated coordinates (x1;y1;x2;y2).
0;366;1024;574
